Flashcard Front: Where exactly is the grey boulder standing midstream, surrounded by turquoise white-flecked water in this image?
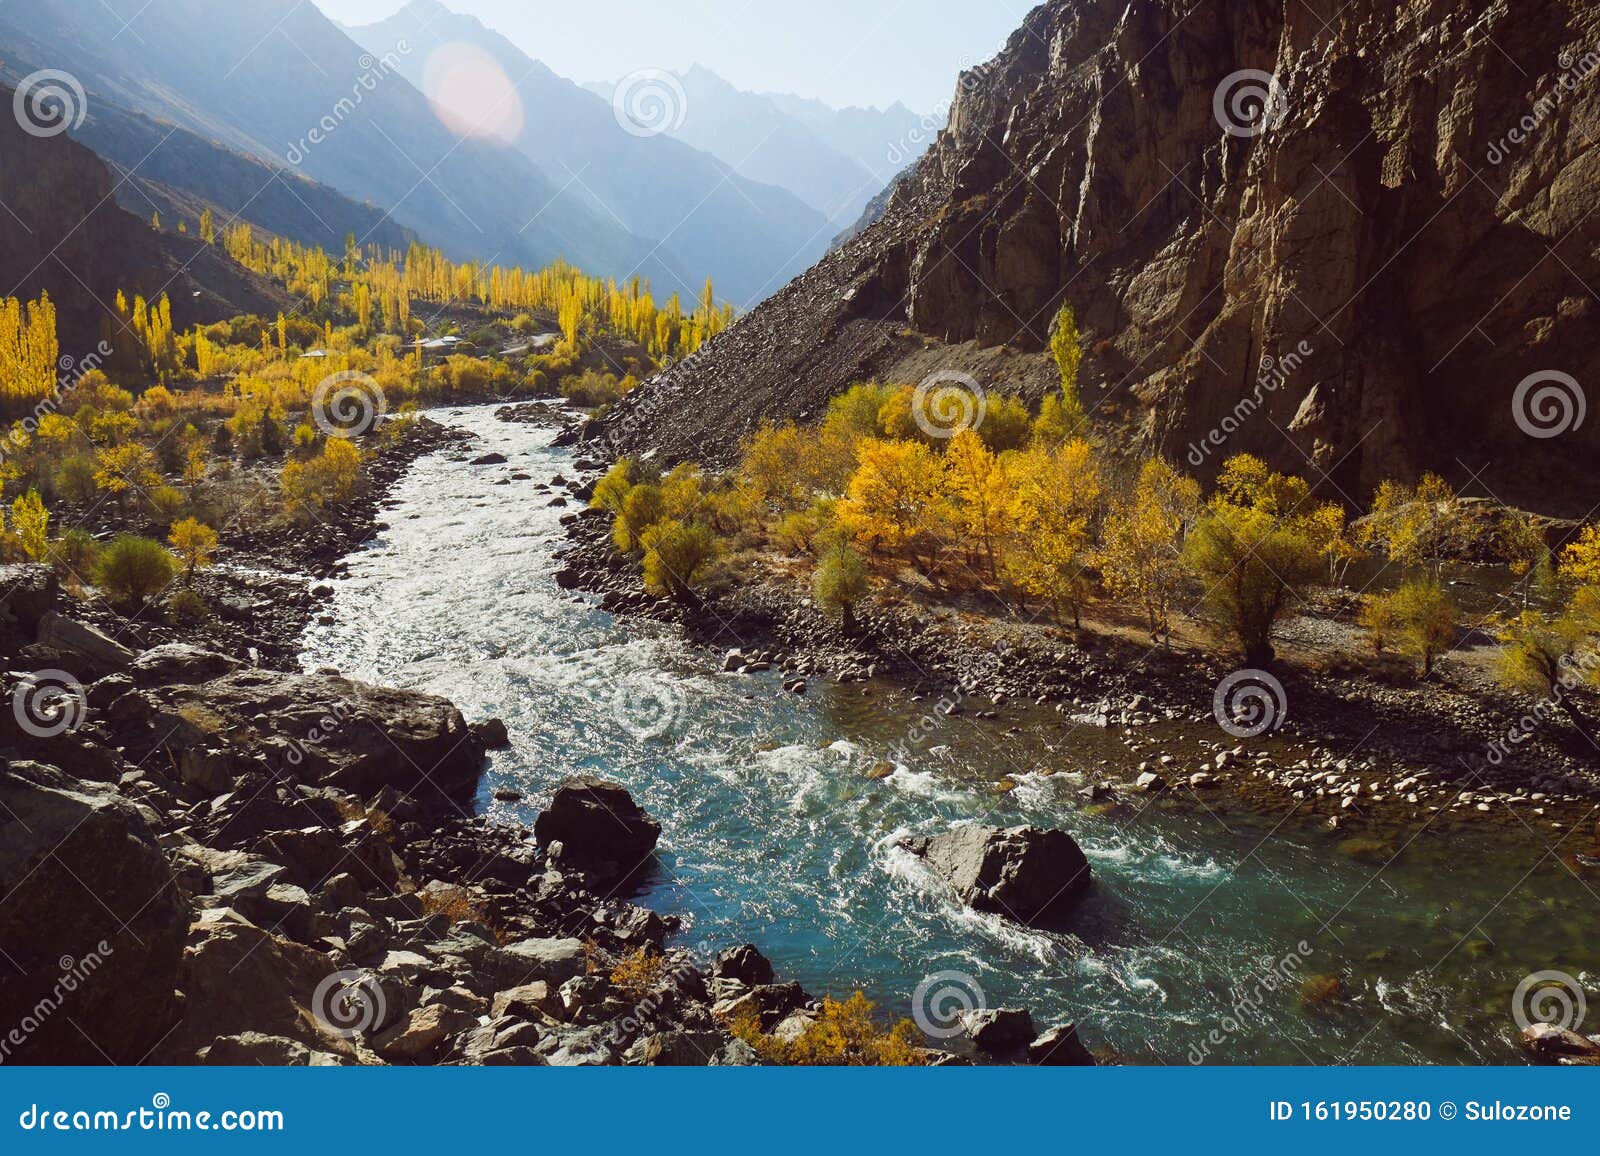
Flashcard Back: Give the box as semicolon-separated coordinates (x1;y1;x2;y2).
906;825;1090;925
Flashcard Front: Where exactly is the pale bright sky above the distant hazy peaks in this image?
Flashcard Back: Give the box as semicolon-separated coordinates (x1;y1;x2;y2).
317;0;1032;112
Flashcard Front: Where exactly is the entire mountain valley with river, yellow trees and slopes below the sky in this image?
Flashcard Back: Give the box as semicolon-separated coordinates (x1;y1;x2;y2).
0;0;1600;1066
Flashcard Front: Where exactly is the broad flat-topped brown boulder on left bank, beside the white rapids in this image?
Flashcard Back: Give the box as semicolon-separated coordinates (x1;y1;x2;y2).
147;669;483;807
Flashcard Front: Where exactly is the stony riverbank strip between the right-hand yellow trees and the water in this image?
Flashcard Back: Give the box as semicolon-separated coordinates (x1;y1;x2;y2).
557;419;1600;838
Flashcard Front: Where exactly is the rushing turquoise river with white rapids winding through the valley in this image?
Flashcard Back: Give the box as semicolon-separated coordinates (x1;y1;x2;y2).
302;407;1600;1065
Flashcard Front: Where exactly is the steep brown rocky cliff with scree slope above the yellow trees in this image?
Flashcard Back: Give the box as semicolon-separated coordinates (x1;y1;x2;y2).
610;0;1600;508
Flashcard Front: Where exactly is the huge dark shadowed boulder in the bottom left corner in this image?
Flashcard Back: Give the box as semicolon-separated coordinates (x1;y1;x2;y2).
0;762;189;1065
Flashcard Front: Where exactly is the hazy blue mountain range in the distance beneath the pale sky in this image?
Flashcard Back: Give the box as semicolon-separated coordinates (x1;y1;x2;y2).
0;0;915;306
